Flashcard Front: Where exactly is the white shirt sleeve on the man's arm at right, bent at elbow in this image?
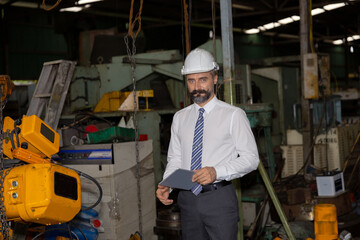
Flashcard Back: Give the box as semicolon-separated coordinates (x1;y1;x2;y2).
215;109;259;181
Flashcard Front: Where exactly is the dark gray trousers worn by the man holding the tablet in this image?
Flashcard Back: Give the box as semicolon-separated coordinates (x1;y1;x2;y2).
178;184;239;240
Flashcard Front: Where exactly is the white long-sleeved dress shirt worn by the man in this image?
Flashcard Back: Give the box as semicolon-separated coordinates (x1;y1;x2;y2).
164;96;259;181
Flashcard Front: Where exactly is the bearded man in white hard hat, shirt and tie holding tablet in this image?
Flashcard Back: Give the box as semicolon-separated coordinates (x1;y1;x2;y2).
156;49;259;240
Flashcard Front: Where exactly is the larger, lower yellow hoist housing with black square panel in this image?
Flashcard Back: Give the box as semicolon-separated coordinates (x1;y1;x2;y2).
4;163;81;225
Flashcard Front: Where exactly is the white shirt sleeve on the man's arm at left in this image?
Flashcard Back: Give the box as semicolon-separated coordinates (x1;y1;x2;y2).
163;114;182;178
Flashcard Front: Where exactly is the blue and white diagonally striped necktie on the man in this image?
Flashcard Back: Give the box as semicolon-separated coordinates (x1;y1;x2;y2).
191;108;205;195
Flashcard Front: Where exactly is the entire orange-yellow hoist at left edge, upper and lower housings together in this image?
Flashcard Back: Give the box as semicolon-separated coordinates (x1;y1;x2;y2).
0;76;81;239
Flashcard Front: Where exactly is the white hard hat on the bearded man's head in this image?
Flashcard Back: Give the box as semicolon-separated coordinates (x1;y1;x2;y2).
181;48;219;75
